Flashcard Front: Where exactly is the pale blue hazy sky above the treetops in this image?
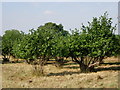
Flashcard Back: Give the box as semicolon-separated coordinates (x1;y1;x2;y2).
0;2;118;35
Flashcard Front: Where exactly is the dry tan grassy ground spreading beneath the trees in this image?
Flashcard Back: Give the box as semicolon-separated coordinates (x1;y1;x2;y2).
0;58;120;88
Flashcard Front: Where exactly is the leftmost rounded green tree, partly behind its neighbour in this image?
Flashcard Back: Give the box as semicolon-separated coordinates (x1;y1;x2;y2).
2;30;21;60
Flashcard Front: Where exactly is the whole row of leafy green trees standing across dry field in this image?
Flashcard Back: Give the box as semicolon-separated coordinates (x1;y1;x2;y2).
2;13;120;72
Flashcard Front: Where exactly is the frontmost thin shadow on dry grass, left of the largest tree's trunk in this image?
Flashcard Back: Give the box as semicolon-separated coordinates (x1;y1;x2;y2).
47;71;80;76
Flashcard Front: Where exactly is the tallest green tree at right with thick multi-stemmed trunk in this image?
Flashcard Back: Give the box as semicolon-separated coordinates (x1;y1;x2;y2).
69;13;119;72
